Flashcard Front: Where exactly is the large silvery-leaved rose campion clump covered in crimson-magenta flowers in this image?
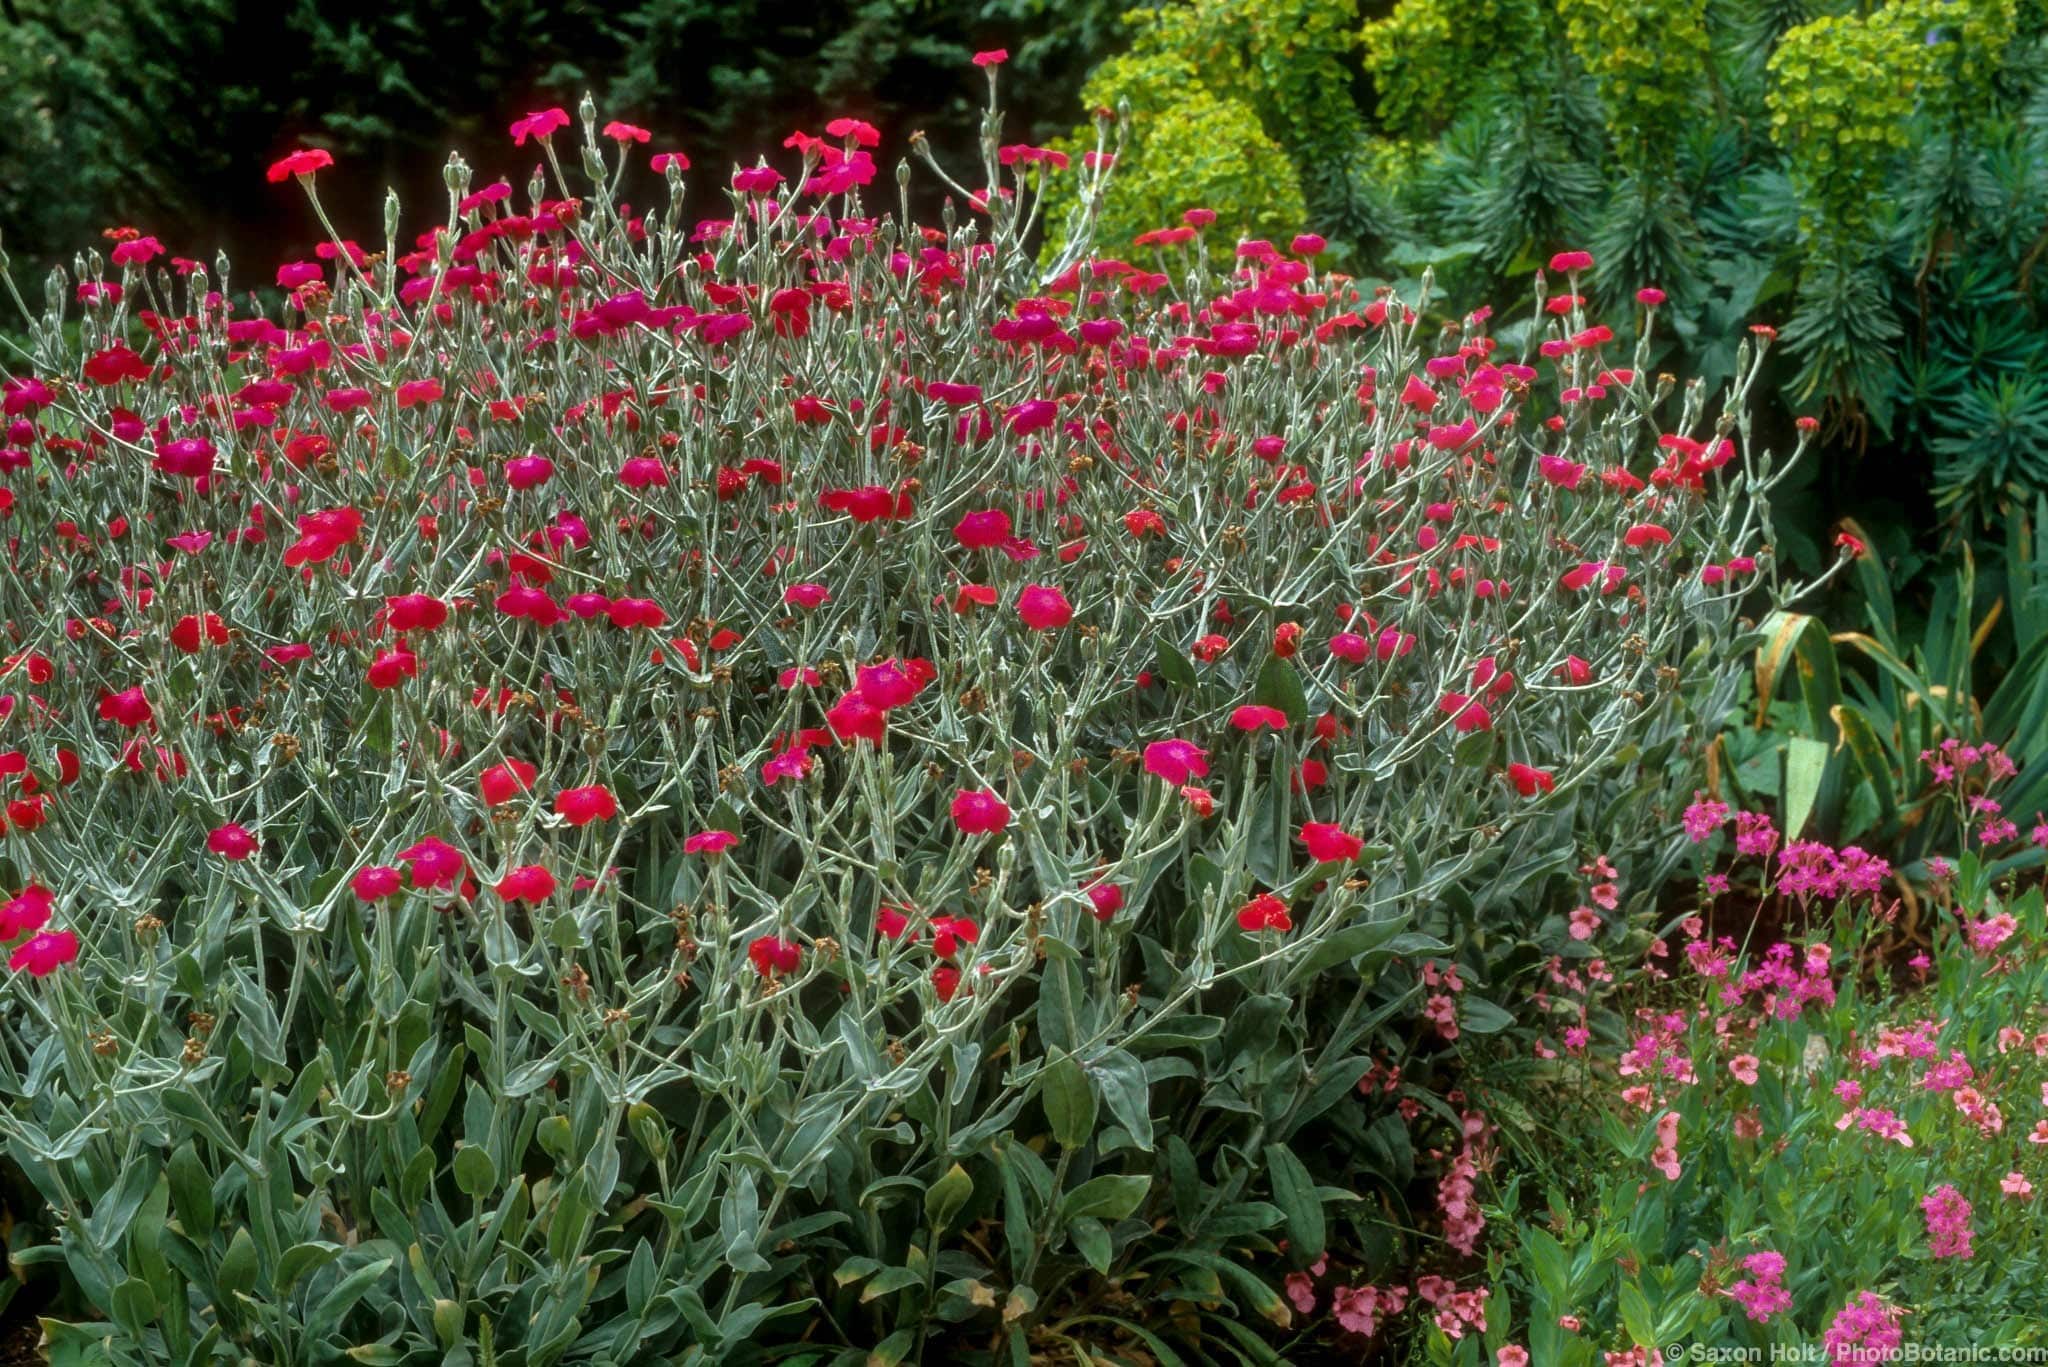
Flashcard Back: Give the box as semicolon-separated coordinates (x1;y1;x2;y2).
0;53;1810;1363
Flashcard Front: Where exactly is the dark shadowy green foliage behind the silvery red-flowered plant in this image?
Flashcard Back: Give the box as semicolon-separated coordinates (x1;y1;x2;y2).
0;0;1116;279
